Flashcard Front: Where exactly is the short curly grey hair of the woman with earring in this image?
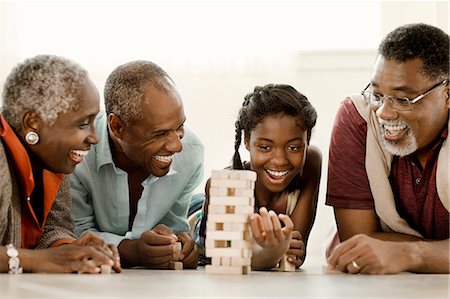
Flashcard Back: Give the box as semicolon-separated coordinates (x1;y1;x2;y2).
2;55;88;129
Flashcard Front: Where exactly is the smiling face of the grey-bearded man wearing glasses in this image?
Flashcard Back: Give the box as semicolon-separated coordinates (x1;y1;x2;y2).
372;56;450;156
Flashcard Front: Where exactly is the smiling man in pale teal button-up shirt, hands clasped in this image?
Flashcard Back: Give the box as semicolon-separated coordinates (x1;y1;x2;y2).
71;61;204;269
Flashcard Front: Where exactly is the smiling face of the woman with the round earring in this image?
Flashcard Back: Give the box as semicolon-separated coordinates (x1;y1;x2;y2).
24;80;99;174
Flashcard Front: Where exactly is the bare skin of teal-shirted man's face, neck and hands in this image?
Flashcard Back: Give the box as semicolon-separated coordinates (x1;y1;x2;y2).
108;83;199;269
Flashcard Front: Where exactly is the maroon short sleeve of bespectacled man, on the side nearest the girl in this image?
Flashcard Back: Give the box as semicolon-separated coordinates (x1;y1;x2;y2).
326;98;374;209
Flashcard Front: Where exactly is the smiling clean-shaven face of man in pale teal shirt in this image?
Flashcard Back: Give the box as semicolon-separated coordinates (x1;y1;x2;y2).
109;85;186;177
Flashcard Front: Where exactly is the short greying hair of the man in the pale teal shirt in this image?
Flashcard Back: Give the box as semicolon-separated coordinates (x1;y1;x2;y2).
103;60;173;126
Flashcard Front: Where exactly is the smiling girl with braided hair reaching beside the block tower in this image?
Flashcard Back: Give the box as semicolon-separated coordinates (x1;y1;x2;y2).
200;84;322;270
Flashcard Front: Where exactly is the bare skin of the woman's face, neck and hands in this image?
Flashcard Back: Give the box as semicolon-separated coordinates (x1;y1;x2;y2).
0;81;121;273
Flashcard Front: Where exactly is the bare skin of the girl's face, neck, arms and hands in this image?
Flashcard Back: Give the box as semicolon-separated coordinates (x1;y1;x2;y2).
204;114;322;270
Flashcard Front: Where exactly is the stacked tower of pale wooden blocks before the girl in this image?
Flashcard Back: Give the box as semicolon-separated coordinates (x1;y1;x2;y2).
205;170;256;274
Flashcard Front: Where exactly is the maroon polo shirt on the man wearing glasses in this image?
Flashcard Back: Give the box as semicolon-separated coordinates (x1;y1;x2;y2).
326;98;450;240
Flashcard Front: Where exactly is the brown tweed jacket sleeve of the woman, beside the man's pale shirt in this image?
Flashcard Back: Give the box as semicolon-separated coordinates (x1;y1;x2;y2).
36;176;75;248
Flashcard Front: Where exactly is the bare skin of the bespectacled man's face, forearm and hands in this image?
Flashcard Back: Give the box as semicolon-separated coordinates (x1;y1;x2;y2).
328;56;450;274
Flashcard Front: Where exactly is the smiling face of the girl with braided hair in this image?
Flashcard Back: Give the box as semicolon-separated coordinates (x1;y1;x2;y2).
245;114;308;193
